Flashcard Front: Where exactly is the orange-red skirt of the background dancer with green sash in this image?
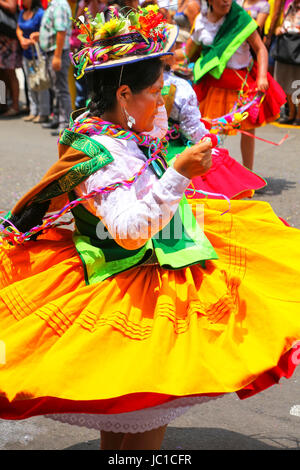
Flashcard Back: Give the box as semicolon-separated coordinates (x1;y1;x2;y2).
193;63;286;125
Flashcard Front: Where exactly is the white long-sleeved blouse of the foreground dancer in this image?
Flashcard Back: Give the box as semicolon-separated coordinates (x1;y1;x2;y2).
76;135;190;250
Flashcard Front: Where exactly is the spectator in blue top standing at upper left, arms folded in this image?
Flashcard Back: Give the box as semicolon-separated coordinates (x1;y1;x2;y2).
17;0;50;123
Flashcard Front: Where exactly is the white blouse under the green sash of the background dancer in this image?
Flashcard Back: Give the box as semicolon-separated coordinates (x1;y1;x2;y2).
191;13;252;70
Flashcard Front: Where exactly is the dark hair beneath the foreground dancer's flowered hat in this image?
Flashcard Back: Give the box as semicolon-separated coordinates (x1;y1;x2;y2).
87;58;163;117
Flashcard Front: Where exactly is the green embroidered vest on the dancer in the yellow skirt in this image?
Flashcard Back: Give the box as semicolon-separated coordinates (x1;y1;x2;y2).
48;126;218;284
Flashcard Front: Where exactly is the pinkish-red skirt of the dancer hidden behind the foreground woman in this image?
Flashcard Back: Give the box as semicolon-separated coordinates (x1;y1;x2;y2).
186;148;266;199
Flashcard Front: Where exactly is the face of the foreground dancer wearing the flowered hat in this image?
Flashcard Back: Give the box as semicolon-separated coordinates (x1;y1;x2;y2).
126;70;164;133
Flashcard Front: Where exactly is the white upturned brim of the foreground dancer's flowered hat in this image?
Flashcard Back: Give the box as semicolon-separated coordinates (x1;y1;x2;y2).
84;25;179;73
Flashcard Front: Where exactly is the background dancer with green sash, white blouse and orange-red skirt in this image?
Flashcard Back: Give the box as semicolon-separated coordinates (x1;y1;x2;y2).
176;0;286;170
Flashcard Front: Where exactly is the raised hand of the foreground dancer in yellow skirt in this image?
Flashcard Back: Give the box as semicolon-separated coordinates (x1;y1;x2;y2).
173;139;212;179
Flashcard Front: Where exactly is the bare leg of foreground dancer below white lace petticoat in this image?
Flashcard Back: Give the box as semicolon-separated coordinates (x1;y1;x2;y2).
120;426;167;450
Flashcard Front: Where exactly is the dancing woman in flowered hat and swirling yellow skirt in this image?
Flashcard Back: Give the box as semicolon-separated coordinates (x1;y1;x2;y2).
0;6;300;450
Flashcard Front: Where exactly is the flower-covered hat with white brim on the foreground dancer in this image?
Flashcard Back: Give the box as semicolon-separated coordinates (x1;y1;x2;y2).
70;5;178;79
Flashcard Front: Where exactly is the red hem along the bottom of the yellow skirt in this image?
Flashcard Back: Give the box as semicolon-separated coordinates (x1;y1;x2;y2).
0;343;300;419
